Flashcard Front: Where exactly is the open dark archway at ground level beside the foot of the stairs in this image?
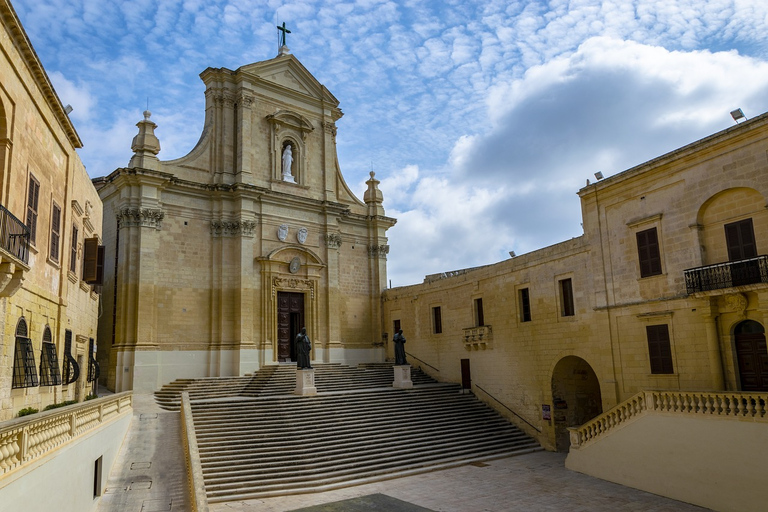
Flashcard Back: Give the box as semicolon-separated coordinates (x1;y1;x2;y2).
552;356;603;452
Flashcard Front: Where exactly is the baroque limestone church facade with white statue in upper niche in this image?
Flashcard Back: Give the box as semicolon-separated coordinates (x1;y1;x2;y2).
94;46;395;391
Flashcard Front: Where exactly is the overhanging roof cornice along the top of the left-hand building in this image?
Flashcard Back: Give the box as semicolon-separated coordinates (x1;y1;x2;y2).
0;0;83;148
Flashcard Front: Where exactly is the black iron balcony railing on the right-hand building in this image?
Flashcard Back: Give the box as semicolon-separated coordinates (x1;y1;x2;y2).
685;255;768;293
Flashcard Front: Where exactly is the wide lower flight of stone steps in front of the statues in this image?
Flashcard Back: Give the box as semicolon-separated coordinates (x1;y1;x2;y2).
183;365;542;503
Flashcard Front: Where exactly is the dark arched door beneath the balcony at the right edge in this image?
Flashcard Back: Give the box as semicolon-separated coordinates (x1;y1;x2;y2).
733;320;768;391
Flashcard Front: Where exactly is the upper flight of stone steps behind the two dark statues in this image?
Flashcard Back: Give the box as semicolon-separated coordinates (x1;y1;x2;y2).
155;363;434;411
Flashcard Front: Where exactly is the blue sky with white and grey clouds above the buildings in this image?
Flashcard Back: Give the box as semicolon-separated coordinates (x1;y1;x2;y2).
13;0;768;286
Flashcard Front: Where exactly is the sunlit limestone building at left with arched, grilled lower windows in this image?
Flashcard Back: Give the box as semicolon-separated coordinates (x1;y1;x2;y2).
0;0;102;420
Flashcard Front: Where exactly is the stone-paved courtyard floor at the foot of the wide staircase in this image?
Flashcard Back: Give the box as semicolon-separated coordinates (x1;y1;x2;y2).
210;452;706;512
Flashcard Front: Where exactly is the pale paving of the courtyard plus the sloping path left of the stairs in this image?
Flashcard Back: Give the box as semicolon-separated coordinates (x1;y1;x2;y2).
98;394;705;512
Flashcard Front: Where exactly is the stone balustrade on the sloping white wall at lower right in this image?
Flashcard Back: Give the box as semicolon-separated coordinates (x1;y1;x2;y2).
568;391;768;449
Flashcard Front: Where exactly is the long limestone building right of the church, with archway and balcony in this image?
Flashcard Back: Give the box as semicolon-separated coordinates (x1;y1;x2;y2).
383;110;768;450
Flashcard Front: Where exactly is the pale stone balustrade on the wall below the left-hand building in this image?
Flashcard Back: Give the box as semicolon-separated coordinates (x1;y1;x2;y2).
0;391;133;478
